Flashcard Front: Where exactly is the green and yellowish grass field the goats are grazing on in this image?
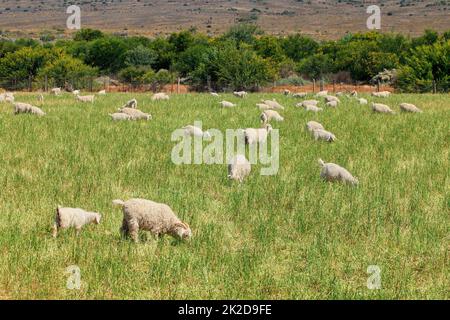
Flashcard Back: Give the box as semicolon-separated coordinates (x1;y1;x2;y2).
0;94;450;299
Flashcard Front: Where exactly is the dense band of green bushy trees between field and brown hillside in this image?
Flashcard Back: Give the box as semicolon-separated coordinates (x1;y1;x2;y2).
0;24;450;92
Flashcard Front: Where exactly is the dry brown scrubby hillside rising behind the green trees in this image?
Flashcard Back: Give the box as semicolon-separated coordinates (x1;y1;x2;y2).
0;0;450;39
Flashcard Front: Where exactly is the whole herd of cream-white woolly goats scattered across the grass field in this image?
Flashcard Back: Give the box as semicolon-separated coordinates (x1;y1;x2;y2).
0;88;422;242
